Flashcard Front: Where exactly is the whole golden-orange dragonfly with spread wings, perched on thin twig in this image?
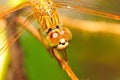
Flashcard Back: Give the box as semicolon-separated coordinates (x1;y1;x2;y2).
0;0;120;61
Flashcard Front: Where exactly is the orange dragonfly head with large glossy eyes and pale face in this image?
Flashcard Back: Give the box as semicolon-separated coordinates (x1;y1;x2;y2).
46;27;72;50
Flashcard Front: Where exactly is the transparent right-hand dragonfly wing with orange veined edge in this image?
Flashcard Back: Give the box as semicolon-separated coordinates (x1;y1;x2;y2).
55;0;120;20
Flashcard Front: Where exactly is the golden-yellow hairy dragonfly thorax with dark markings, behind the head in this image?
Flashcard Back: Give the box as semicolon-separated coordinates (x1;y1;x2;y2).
32;0;60;33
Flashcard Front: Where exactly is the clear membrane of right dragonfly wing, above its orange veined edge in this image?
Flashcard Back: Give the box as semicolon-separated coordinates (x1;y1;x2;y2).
55;0;120;15
